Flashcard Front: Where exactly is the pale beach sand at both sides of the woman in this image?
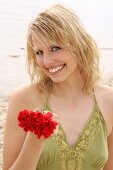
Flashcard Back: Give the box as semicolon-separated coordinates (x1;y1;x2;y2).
0;77;113;170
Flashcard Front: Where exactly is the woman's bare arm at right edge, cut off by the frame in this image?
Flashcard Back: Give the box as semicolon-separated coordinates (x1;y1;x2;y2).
96;85;113;170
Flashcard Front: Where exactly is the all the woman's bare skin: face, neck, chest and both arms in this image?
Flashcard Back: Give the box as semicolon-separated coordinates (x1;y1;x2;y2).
3;37;113;170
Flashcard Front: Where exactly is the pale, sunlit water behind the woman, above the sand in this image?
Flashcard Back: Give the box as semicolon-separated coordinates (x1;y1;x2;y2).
0;0;113;96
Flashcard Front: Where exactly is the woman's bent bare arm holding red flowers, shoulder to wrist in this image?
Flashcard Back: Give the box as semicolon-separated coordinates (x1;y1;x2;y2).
3;87;45;170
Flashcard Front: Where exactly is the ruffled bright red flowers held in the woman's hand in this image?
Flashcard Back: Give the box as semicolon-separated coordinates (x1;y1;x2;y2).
18;110;58;139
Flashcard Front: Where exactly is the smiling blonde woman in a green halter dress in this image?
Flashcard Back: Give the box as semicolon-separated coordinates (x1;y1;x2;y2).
3;5;113;170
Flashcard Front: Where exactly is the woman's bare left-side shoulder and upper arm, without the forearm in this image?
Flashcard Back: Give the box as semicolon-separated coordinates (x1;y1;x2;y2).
3;84;42;169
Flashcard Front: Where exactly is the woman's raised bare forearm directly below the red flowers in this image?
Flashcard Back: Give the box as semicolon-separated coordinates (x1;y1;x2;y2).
9;132;44;170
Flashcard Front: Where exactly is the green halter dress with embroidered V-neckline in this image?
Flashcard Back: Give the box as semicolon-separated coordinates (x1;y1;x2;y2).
36;95;108;170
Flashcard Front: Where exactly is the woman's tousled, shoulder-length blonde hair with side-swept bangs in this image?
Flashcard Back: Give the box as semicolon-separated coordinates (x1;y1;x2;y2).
27;4;99;94
